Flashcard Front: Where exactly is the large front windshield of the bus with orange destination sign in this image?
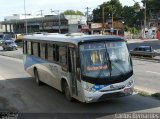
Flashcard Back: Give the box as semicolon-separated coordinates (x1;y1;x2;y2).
79;41;132;78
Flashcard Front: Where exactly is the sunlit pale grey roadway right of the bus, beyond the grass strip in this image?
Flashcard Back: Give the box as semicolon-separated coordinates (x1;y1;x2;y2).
133;59;160;94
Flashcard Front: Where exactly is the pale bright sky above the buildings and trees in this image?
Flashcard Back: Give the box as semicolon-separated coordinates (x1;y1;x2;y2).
0;0;141;21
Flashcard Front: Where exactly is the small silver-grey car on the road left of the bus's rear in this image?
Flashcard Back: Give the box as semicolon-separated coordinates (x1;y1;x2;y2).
2;40;17;50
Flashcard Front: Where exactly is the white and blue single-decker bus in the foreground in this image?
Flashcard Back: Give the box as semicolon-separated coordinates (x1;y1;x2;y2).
23;34;134;103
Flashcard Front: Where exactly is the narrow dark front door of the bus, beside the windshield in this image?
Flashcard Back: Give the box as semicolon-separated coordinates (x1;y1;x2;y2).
69;48;78;96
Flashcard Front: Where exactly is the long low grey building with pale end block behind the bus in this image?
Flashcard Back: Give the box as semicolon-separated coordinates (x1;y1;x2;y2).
0;14;87;34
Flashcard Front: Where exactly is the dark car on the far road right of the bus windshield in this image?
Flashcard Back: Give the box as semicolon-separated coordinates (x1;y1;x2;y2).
130;46;156;58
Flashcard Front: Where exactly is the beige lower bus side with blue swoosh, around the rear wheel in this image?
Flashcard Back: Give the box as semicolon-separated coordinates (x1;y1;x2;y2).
24;56;58;88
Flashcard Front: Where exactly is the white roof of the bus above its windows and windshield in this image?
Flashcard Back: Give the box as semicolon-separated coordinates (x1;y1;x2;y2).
23;33;125;44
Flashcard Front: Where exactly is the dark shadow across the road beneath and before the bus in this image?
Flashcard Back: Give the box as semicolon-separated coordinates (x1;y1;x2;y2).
0;78;160;118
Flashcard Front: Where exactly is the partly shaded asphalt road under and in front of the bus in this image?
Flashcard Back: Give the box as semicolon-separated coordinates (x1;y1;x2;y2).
0;56;160;118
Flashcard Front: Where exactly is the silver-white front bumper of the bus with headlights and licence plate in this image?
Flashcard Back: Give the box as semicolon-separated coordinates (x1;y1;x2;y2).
84;78;134;103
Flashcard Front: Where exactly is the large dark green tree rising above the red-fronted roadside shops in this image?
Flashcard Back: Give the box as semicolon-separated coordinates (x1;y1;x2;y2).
93;0;144;28
